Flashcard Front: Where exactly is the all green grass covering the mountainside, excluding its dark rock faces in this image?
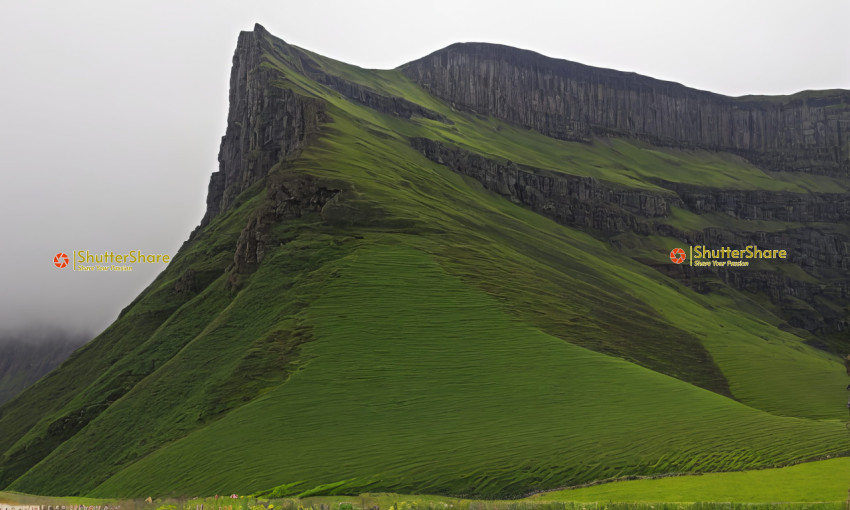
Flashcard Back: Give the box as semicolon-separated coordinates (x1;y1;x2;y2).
0;28;850;496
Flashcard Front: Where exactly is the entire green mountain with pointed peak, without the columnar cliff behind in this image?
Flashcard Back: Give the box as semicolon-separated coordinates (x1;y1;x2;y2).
0;25;850;497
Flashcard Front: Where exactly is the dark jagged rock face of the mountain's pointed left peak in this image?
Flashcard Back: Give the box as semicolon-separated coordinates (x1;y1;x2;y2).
201;25;328;227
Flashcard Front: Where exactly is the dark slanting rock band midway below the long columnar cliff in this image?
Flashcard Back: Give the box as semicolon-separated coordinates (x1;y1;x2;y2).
410;138;682;233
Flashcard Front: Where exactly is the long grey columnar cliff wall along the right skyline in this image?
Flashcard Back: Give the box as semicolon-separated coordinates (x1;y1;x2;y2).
400;43;850;175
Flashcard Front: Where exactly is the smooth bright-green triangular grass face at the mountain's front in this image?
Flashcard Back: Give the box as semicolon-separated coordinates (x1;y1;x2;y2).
88;245;846;497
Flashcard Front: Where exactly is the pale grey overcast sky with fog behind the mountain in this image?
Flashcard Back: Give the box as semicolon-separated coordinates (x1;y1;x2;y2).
0;0;850;342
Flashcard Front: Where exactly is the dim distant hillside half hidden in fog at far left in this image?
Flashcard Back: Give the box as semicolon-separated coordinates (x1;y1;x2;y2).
0;332;90;405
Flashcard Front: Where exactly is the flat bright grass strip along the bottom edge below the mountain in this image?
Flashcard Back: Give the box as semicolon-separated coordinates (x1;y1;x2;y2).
6;452;850;510
